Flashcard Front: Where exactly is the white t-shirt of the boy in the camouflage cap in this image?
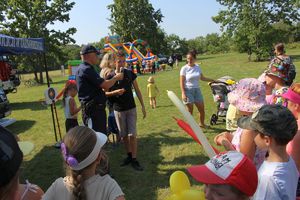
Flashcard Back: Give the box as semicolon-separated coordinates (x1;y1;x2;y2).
252;157;299;200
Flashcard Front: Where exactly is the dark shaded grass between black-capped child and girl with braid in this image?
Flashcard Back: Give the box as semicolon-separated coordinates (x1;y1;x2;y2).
20;146;65;191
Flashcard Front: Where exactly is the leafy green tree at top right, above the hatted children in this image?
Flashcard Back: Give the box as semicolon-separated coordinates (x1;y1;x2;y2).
213;0;300;60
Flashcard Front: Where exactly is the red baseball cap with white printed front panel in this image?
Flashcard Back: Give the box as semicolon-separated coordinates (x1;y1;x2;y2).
187;151;258;196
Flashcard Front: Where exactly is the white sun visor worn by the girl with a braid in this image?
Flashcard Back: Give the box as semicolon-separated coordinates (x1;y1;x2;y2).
60;126;107;171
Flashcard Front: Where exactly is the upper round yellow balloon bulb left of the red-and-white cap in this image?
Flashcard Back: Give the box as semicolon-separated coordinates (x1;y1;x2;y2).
170;171;191;194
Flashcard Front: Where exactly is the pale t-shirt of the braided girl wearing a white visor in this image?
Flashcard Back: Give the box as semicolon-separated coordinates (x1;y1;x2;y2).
42;175;124;200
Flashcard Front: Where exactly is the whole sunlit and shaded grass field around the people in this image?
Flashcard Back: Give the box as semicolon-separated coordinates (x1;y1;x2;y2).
8;49;300;200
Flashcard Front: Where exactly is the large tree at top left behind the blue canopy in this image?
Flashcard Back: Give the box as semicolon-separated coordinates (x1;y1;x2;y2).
0;0;76;83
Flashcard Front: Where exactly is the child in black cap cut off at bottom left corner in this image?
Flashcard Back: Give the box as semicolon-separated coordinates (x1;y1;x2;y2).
0;126;44;200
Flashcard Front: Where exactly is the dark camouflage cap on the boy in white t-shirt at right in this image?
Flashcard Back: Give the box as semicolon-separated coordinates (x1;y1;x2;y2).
238;105;298;140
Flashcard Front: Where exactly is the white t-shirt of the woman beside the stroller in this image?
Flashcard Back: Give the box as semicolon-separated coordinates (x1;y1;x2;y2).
180;64;202;88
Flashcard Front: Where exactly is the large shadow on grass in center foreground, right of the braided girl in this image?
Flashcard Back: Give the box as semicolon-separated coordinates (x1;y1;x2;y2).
109;130;208;200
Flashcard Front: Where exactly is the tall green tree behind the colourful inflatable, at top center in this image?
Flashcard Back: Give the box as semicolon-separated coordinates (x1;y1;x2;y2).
108;0;164;53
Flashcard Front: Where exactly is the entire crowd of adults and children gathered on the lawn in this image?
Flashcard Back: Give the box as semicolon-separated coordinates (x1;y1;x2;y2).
0;41;300;200
